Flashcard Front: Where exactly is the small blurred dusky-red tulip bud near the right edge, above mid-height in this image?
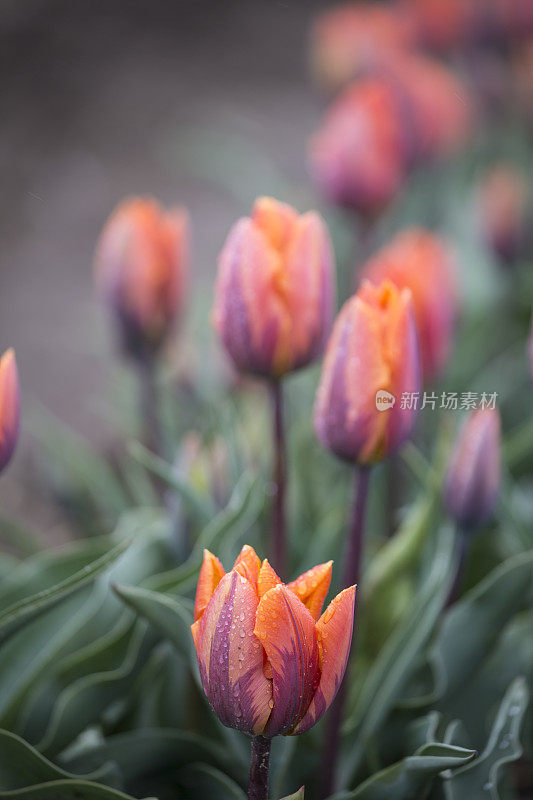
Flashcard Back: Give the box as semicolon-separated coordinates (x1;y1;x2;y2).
479;164;527;263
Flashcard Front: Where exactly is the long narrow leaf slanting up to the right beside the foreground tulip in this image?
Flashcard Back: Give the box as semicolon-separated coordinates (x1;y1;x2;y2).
341;527;453;786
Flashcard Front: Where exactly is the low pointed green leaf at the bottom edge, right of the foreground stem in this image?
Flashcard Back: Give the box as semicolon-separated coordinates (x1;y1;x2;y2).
331;742;476;800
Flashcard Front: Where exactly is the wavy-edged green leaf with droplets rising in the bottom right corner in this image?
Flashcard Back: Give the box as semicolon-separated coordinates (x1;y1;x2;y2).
446;678;529;800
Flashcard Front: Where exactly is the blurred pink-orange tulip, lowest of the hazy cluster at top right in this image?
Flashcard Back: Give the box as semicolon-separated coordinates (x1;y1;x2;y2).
309;77;407;217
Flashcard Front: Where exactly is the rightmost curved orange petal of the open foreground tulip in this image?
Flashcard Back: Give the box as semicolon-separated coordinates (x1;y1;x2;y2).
292;586;355;734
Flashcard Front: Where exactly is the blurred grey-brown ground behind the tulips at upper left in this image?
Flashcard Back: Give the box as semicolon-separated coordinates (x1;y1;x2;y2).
0;0;327;536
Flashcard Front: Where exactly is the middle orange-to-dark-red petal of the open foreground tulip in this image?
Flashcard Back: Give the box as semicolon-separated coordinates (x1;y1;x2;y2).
254;584;320;736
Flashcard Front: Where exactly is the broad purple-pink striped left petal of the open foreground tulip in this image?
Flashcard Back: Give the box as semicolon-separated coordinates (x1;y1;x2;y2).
193;570;272;734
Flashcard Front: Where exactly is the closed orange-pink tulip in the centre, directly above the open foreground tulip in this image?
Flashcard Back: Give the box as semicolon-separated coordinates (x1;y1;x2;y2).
213;197;335;378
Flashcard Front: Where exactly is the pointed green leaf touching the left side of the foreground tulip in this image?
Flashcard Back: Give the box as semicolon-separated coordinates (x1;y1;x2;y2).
113;585;193;660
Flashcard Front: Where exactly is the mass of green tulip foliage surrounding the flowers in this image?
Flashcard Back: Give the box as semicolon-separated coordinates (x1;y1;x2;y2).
0;59;533;800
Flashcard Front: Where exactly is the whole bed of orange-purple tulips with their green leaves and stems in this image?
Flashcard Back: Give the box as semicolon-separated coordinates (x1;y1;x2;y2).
0;0;533;800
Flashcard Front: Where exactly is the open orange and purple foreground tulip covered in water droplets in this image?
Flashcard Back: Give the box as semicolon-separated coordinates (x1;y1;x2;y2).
192;545;355;738
